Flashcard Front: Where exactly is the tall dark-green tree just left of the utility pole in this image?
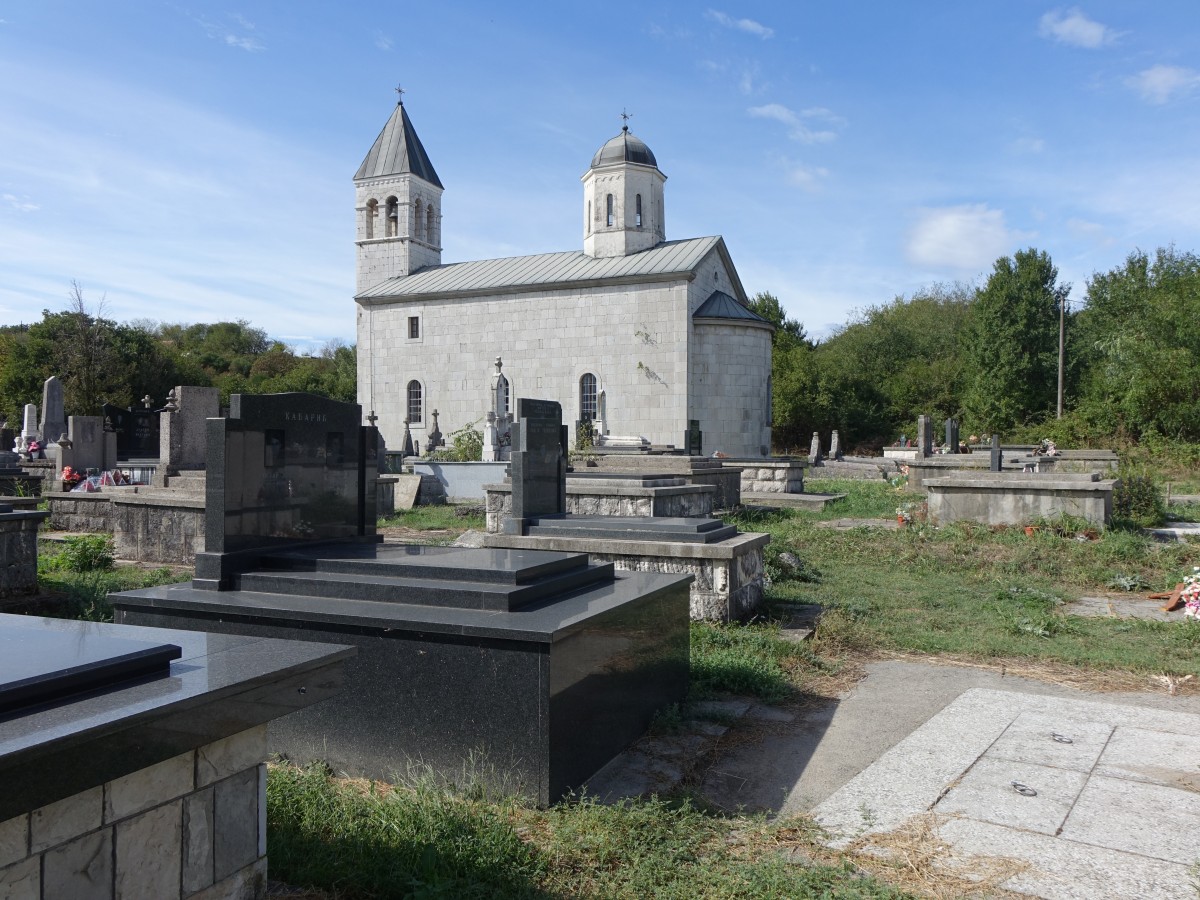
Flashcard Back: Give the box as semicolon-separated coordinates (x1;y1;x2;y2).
965;247;1070;431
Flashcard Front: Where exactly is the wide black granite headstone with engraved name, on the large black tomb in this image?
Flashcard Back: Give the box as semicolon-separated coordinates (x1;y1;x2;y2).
196;394;379;588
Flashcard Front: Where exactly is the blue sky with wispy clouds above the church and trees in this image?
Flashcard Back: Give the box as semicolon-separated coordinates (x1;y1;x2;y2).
0;0;1200;349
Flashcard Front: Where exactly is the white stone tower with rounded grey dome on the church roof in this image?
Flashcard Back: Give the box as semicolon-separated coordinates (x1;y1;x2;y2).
582;125;667;258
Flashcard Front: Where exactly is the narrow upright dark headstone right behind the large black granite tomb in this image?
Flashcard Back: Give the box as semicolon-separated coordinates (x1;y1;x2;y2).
503;397;568;534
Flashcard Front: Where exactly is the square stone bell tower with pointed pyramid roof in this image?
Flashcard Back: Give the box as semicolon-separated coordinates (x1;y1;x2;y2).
354;88;443;294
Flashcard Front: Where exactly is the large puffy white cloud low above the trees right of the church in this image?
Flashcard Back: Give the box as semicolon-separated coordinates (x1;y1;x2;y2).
905;203;1033;271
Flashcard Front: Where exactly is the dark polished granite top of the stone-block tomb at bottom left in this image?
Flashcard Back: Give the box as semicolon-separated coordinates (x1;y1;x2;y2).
0;614;355;822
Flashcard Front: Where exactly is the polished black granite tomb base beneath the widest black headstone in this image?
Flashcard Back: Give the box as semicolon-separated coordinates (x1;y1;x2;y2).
119;545;691;804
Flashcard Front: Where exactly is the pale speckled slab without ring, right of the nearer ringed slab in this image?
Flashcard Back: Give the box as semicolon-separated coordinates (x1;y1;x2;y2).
1062;775;1200;865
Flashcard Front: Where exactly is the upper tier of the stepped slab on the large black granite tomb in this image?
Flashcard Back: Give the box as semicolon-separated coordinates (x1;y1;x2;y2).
259;544;588;586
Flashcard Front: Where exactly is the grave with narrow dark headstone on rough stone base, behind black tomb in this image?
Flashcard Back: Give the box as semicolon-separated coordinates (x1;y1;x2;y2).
485;398;770;622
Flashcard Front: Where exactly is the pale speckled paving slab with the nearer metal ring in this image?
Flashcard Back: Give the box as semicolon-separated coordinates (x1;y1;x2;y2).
934;757;1087;834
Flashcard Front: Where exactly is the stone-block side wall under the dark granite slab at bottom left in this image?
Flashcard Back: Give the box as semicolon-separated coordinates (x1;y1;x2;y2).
0;725;266;900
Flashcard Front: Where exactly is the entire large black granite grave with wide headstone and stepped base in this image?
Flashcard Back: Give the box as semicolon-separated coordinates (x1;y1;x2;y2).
112;395;689;804
